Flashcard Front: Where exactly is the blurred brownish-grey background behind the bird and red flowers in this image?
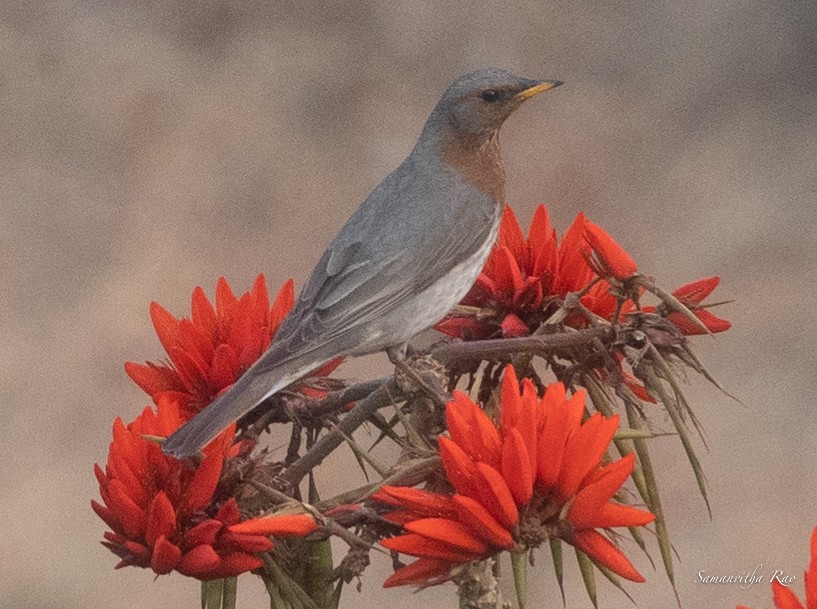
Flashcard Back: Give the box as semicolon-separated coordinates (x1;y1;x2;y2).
0;0;817;609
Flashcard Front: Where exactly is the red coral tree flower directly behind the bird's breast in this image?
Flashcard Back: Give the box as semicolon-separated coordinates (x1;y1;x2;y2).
436;205;637;339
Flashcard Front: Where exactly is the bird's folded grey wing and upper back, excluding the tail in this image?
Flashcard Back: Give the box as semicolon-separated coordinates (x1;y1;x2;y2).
258;166;501;369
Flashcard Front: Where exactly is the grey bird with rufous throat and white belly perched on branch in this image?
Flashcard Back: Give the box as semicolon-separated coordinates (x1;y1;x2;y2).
163;68;562;459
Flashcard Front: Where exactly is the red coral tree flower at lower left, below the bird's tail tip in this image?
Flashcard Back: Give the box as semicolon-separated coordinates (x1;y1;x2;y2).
91;398;316;580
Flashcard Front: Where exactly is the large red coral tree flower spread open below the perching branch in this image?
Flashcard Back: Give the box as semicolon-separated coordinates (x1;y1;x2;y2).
375;367;655;586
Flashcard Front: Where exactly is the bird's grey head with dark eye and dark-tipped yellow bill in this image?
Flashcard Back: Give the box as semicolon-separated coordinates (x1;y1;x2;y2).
423;68;562;140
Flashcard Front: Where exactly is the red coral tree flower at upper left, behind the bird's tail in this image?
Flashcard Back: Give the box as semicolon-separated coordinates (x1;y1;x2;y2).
125;275;341;420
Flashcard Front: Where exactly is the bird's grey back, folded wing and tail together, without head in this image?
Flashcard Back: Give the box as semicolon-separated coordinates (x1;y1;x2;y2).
163;160;499;458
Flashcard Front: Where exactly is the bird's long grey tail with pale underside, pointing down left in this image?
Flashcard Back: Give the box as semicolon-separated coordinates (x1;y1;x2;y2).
162;360;316;459
